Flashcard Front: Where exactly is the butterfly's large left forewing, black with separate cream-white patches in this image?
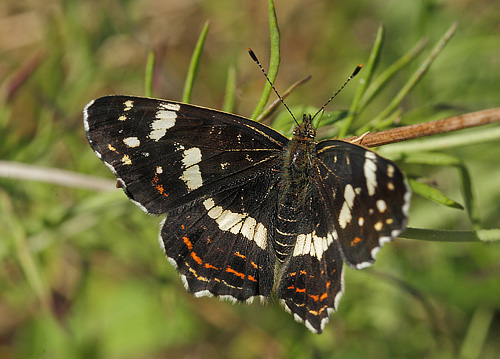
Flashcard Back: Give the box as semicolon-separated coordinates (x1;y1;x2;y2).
84;96;288;214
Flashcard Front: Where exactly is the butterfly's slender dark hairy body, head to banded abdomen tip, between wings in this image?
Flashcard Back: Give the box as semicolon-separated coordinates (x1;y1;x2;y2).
275;115;316;261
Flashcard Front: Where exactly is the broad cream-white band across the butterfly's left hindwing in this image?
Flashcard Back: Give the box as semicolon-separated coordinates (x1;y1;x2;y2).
203;198;267;249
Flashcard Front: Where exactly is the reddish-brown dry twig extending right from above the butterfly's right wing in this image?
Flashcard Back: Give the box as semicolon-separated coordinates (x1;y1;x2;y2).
344;107;500;147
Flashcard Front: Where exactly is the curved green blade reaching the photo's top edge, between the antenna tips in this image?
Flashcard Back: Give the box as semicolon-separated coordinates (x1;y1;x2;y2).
250;0;281;119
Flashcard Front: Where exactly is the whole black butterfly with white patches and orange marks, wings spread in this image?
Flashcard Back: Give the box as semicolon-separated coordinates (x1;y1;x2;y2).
84;96;411;333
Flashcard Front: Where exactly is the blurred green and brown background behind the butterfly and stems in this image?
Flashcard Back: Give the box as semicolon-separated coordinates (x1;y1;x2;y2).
0;0;500;359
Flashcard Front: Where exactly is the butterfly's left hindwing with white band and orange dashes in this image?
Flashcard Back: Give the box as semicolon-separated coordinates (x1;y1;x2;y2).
160;170;278;301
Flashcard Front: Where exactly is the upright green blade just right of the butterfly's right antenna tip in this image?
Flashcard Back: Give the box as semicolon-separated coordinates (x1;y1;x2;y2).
339;26;384;138
